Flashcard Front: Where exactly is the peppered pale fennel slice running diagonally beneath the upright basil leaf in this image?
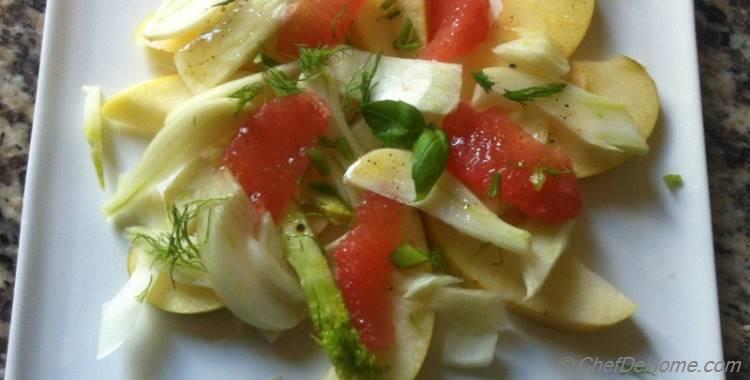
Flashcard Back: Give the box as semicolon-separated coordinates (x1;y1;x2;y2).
344;149;531;254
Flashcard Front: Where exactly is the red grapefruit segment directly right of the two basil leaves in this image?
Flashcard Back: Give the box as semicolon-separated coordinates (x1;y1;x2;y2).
443;103;582;222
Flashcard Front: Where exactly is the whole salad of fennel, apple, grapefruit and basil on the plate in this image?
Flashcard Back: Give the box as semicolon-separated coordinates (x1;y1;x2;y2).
84;0;659;380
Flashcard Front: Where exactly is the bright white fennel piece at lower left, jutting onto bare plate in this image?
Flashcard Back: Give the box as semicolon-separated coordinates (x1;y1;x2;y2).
96;251;159;360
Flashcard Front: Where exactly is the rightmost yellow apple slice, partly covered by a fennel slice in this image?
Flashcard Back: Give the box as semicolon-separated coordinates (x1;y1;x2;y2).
550;56;659;177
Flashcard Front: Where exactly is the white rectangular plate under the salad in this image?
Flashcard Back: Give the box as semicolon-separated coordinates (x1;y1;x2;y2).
7;0;723;380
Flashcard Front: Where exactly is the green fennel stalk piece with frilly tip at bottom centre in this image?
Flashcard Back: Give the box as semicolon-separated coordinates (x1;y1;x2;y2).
283;210;381;380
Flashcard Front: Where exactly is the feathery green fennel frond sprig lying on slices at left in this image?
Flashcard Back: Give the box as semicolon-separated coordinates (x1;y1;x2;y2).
131;198;226;286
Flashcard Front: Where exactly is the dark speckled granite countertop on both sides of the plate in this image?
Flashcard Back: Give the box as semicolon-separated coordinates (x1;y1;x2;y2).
0;0;750;379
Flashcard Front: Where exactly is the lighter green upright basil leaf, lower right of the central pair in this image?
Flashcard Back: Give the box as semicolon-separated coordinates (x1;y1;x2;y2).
411;128;450;201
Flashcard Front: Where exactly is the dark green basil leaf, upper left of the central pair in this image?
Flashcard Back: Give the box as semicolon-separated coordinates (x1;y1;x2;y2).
360;100;425;149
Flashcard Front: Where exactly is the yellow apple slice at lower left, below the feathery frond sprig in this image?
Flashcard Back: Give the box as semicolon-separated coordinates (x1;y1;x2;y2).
128;247;224;314
